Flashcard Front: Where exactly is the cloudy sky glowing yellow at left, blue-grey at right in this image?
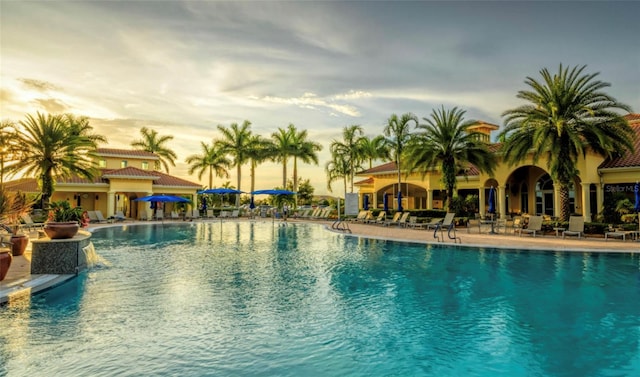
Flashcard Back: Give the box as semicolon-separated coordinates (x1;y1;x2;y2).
0;0;640;195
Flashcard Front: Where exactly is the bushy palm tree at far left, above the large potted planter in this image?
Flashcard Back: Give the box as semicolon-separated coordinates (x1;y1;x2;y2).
11;112;104;207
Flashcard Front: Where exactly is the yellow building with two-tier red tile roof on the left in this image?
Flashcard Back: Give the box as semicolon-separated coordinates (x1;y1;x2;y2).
5;148;202;219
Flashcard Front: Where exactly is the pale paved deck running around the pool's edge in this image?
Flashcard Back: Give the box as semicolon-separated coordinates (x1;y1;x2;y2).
0;218;640;304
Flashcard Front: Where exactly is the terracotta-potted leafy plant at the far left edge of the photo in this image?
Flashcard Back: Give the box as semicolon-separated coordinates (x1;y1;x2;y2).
0;189;33;256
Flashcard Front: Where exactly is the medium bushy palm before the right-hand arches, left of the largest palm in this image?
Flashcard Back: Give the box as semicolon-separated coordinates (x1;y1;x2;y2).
407;106;497;211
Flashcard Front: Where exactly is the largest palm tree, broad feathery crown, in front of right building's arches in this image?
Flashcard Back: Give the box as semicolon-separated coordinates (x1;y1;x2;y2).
499;64;634;220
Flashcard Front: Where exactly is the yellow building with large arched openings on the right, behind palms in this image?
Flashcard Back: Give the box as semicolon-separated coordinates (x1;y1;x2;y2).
355;114;640;221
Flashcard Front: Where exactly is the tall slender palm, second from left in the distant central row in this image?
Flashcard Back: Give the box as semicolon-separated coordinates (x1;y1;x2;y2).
215;120;252;206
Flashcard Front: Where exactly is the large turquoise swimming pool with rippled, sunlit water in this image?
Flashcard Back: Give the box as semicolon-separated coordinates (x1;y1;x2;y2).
0;222;640;377
